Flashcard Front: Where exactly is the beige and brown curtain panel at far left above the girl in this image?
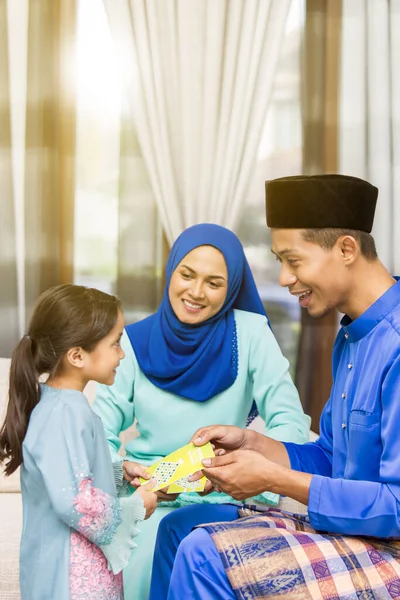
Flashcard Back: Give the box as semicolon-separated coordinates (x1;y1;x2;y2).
0;0;76;356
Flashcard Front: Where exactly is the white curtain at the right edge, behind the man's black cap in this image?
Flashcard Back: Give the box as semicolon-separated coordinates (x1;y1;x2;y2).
340;0;400;274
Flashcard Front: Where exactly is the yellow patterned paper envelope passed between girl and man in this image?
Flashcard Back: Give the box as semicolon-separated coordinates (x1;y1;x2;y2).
140;442;214;494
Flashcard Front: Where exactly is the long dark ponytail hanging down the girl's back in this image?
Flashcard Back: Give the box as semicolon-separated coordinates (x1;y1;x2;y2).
0;335;40;475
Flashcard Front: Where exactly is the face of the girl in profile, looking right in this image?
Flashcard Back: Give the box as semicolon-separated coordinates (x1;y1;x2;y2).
84;312;125;385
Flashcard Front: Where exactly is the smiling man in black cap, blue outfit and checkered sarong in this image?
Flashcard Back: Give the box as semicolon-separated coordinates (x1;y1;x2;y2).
151;175;400;600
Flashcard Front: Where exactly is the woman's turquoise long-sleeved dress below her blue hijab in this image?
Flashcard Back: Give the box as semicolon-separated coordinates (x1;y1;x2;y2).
93;309;310;600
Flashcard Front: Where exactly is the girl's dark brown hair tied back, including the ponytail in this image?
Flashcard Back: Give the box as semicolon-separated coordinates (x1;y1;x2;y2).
0;284;120;475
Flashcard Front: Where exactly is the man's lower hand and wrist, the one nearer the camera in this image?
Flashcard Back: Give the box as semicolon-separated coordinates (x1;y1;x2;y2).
202;450;312;504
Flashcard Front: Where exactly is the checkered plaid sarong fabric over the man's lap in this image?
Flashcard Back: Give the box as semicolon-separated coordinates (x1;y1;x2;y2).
202;509;400;600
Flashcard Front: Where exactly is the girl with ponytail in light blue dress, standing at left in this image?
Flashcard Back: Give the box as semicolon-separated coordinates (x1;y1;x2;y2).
0;285;157;600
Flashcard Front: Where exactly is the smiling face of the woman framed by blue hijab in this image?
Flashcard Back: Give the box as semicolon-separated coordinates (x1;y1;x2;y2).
168;246;228;325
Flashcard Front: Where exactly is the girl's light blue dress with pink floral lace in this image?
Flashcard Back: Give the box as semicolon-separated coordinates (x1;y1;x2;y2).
20;385;145;600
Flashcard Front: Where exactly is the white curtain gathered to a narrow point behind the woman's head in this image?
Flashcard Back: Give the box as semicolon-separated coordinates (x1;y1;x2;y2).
104;0;290;242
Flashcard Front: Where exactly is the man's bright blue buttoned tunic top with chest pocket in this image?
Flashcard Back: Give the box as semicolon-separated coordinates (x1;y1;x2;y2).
285;282;400;537
